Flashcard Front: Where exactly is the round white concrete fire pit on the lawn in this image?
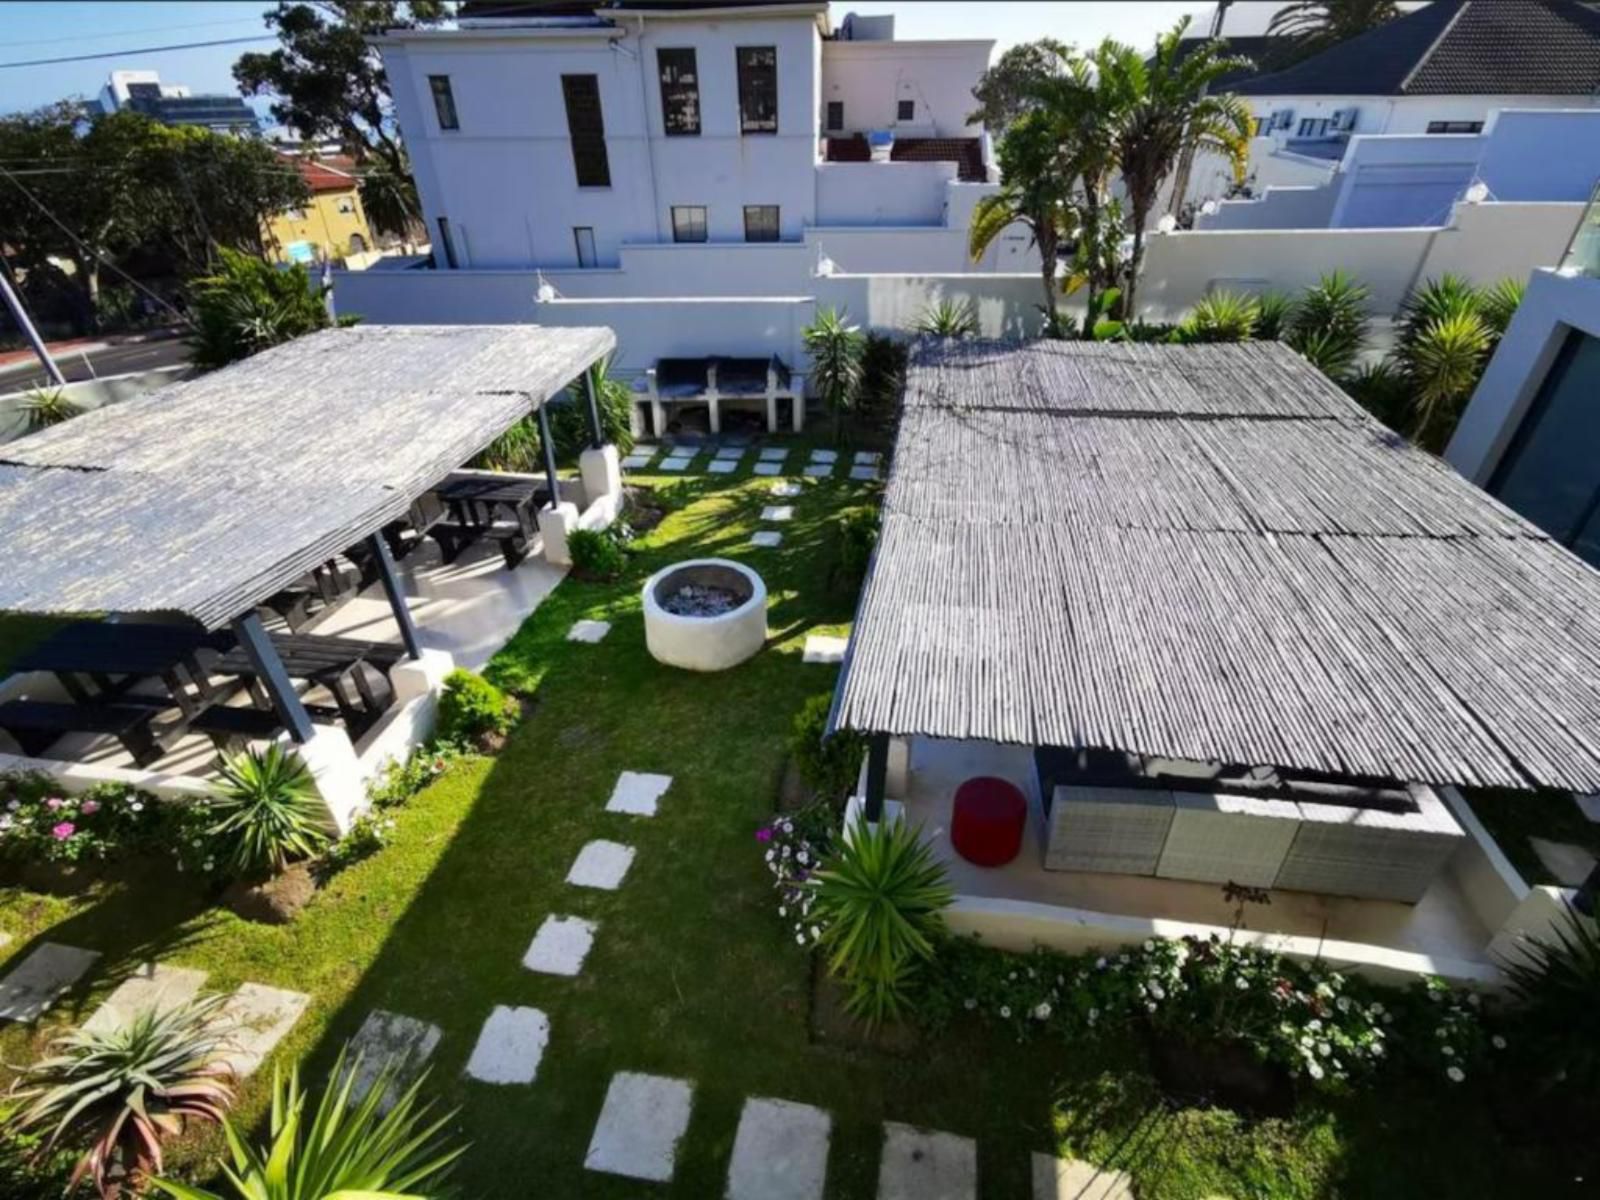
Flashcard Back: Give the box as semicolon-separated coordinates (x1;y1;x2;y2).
643;558;766;670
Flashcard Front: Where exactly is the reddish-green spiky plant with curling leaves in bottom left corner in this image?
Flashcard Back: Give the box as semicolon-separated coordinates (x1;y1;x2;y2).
6;997;234;1197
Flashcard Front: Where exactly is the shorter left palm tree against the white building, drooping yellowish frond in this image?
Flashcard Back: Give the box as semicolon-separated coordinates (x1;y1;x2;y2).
968;110;1078;338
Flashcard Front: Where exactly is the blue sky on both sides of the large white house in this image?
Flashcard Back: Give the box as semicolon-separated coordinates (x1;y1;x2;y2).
0;0;1235;112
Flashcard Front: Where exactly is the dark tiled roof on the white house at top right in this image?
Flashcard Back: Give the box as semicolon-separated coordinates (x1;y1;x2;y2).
1234;0;1600;96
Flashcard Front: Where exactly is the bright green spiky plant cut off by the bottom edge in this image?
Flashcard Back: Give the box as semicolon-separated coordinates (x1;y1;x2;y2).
150;1051;467;1200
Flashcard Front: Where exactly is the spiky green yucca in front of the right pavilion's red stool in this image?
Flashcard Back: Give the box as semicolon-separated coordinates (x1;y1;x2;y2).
811;821;954;1024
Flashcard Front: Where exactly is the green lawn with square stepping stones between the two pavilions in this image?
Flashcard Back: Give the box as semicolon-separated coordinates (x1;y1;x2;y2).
0;454;1554;1200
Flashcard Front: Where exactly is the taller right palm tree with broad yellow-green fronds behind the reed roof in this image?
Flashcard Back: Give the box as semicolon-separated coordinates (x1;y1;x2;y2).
1094;18;1253;320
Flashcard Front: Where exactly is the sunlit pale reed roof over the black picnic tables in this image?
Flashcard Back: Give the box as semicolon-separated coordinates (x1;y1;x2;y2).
0;325;616;629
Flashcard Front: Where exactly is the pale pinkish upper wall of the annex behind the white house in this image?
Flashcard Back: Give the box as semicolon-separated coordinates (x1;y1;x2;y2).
816;42;994;138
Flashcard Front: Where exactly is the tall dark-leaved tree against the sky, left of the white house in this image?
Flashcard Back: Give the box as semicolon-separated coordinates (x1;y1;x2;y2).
234;0;448;174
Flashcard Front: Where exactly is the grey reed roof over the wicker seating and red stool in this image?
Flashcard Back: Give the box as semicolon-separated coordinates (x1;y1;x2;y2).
834;342;1600;792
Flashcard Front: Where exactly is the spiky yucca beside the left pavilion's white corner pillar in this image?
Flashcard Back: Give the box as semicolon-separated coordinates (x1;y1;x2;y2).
210;744;330;878
